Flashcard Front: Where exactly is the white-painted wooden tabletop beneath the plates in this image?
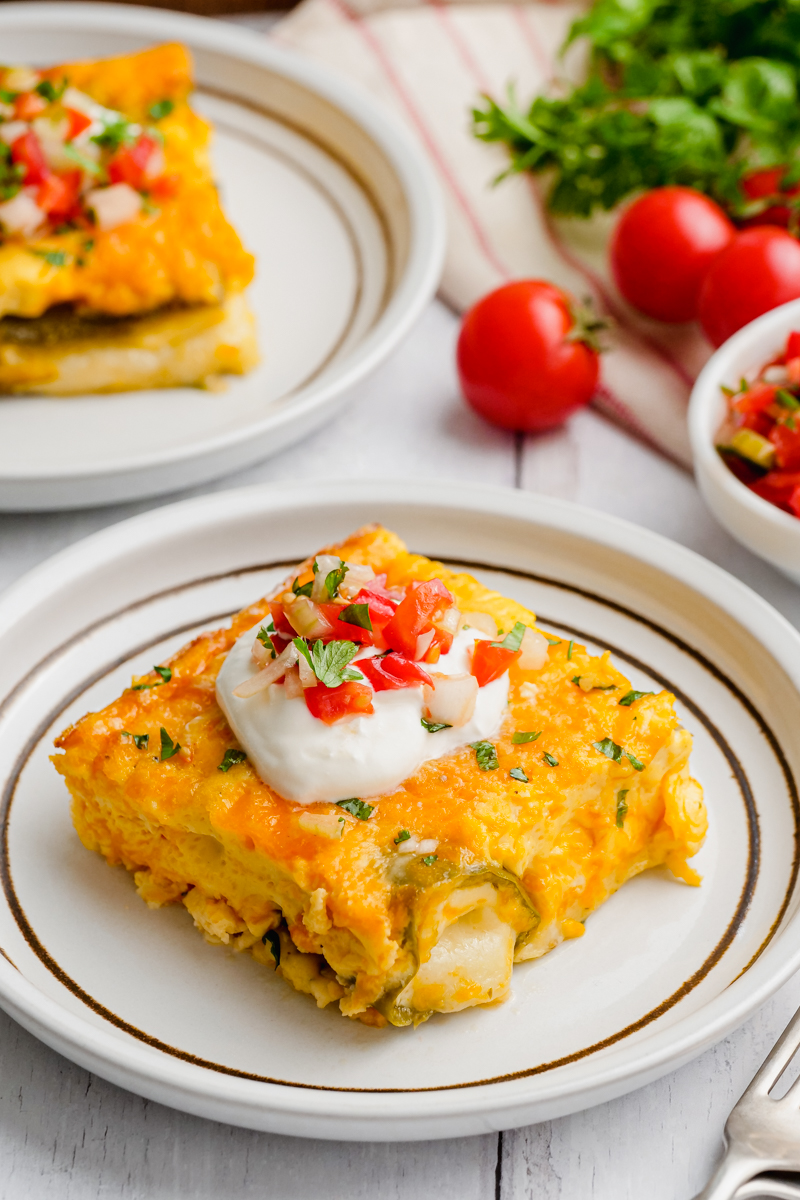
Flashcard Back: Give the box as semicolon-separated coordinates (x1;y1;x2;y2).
0;288;800;1200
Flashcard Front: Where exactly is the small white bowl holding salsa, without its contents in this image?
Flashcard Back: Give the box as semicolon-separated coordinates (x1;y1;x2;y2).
688;300;800;583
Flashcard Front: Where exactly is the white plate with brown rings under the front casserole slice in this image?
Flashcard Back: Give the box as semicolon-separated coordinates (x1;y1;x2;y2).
0;482;800;1141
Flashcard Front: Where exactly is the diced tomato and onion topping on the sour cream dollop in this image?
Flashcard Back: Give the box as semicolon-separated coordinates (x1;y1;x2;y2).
234;554;548;730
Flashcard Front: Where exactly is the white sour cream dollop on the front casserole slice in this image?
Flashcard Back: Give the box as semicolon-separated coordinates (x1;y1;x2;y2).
217;625;509;804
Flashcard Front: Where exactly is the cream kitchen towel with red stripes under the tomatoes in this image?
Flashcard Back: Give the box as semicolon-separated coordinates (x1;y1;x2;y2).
271;0;709;463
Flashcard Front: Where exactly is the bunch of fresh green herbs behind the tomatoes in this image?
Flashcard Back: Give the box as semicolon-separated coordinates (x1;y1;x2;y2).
473;0;800;217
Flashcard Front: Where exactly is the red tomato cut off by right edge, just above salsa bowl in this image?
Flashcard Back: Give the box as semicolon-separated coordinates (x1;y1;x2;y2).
698;226;800;346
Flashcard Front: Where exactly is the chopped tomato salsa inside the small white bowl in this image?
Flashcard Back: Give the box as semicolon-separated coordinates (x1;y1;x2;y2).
717;332;800;517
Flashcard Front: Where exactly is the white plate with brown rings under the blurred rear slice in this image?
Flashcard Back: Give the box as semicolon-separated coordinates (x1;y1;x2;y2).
0;2;445;510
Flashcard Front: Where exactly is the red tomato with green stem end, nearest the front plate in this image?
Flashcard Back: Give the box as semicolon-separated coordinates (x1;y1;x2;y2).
456;280;600;432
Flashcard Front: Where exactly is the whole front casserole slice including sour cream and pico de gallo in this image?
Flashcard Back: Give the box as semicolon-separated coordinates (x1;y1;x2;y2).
53;527;706;1026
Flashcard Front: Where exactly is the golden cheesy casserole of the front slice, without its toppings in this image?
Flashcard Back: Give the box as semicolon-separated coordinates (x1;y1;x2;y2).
53;527;706;1025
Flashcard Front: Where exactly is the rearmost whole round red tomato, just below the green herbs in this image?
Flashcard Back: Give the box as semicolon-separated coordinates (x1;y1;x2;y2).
610;187;736;323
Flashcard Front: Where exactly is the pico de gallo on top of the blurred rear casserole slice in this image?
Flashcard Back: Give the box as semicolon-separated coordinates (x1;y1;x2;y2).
0;67;176;240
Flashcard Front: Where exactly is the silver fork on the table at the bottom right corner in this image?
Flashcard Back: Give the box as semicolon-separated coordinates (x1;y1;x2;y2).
694;1009;800;1200
